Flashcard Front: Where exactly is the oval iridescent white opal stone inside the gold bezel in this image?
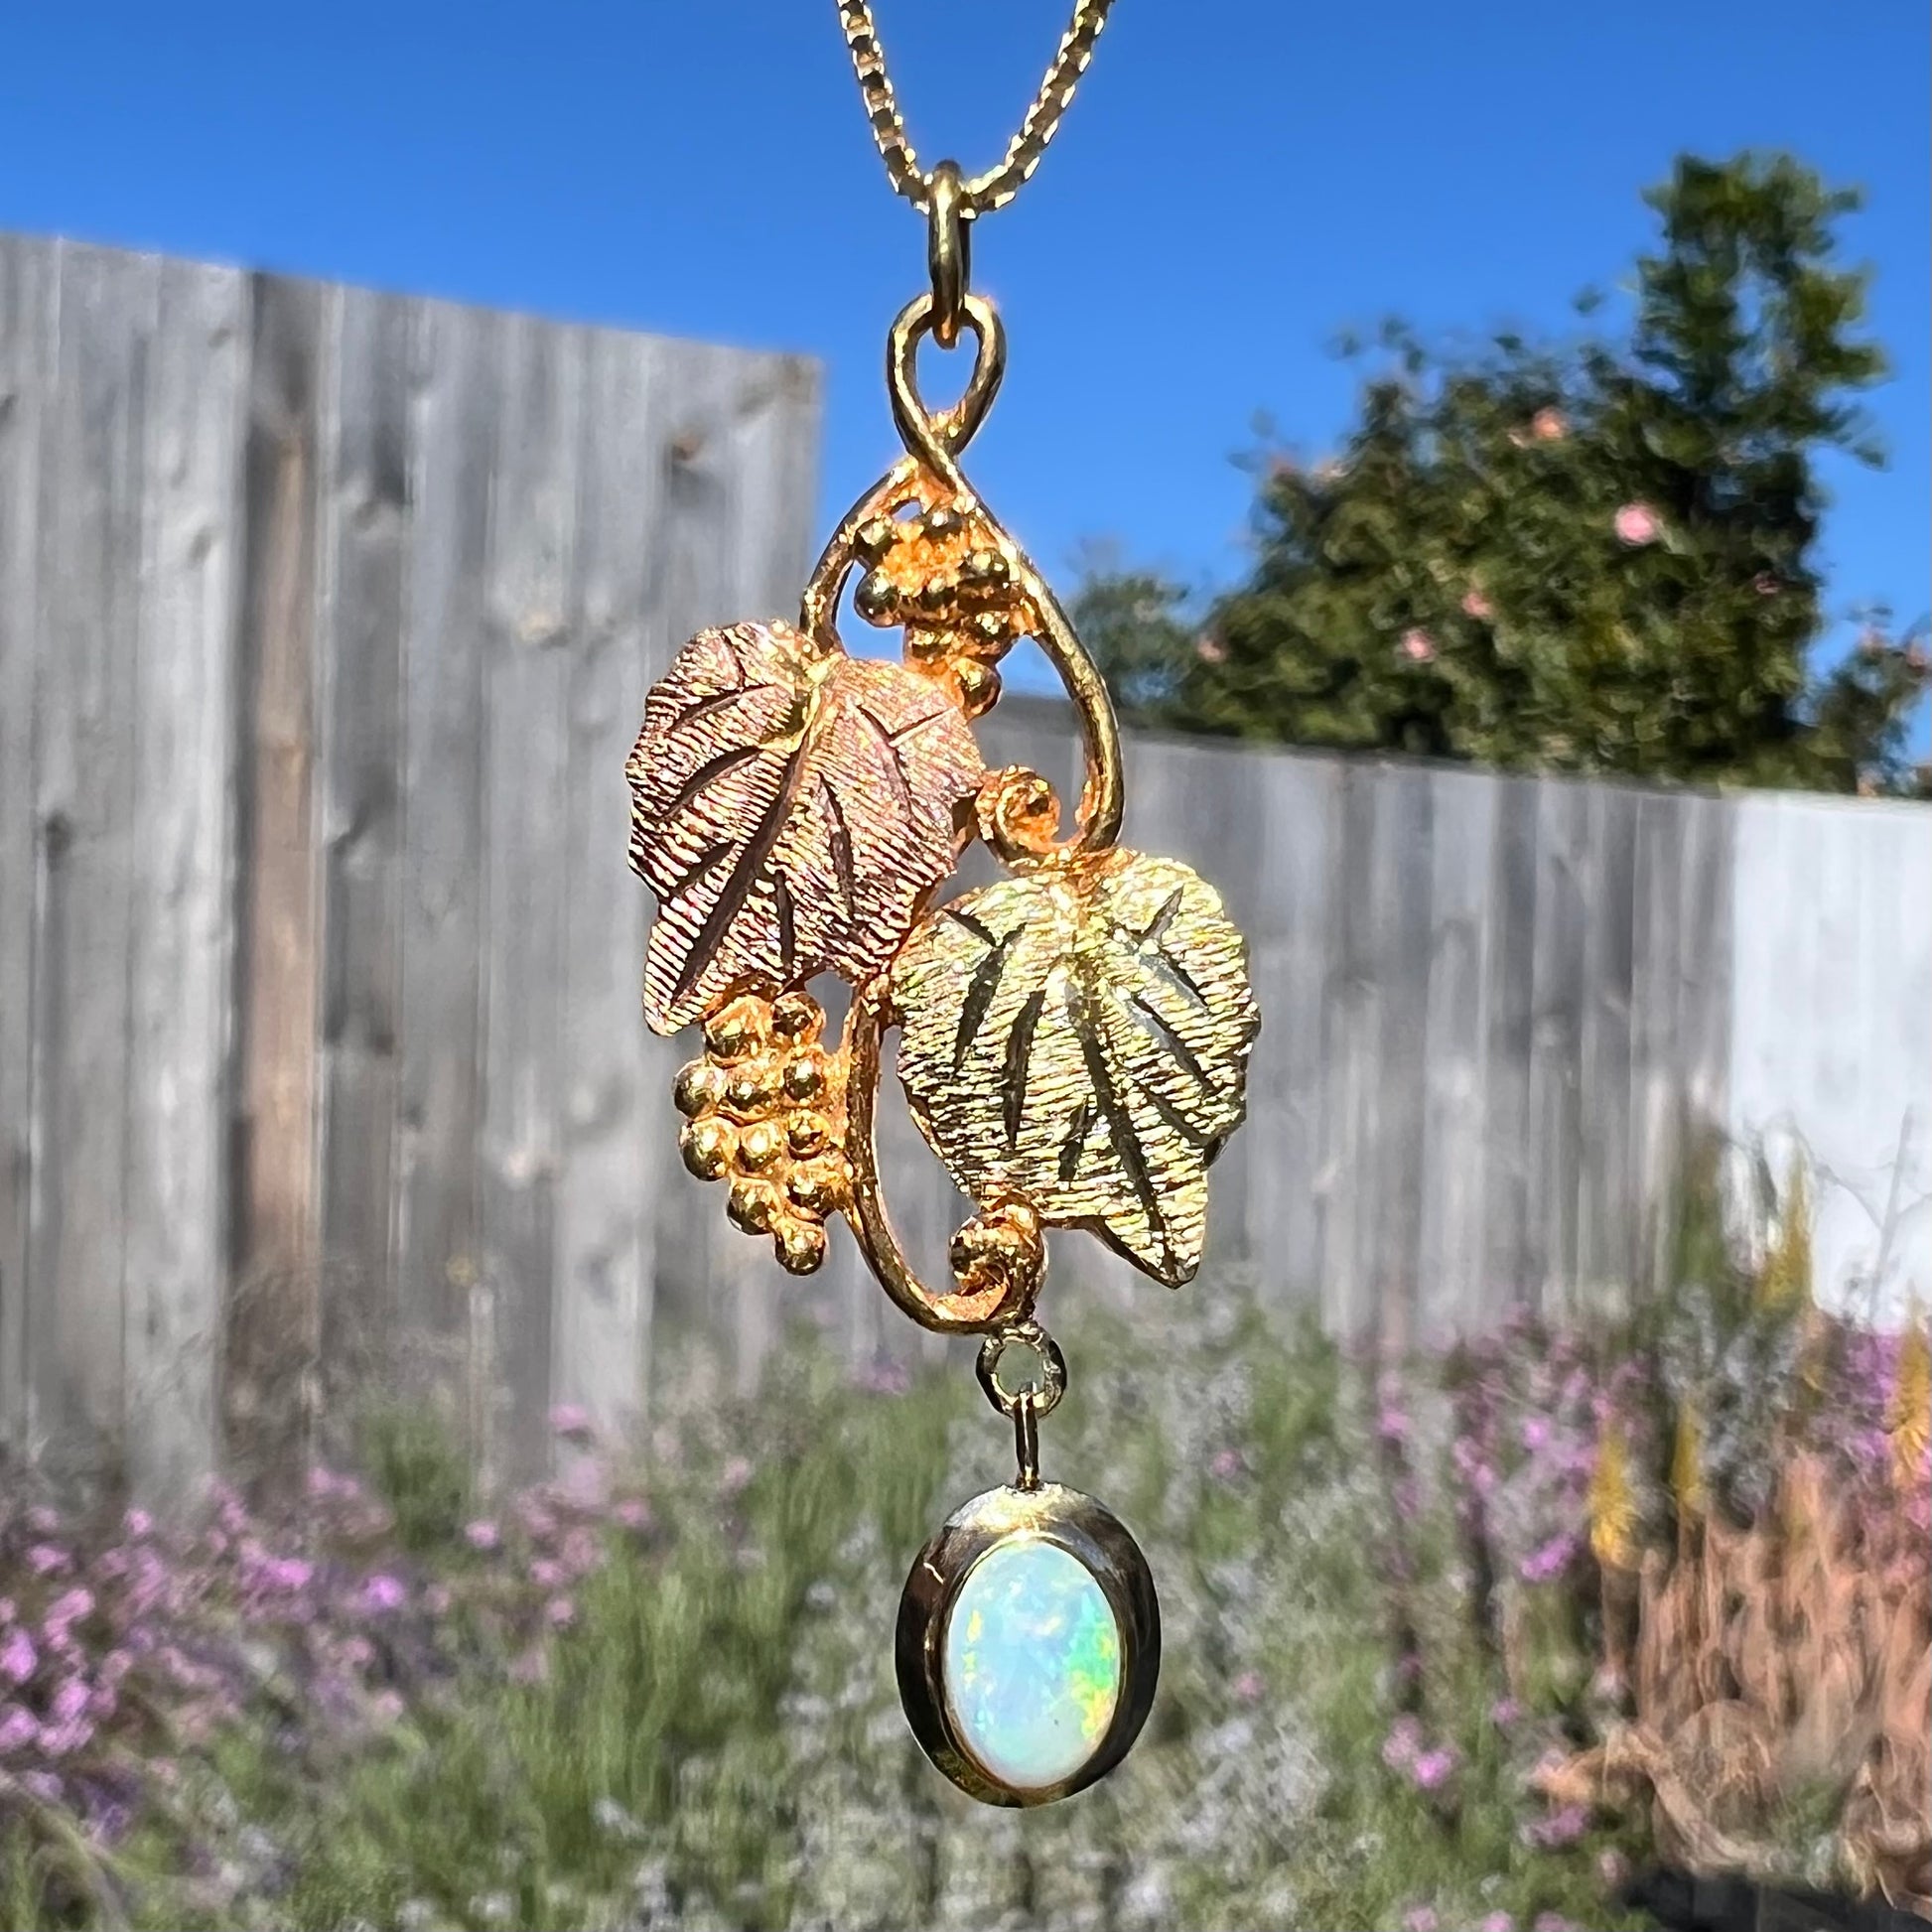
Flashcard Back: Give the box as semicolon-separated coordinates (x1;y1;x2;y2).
945;1536;1121;1791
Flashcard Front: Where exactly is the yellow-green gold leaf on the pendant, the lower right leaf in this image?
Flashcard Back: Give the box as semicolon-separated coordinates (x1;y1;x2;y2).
893;850;1260;1287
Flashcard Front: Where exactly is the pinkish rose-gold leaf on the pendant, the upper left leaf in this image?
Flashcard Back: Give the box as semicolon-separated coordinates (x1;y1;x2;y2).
626;624;985;1034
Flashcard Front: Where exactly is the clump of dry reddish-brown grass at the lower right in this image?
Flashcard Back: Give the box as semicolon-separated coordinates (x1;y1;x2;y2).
1538;1452;1932;1916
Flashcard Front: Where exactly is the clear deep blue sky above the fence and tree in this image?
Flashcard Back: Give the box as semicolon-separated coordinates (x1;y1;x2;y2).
0;0;1932;687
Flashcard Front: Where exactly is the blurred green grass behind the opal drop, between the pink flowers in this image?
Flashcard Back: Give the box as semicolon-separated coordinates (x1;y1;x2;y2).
0;1291;1653;1932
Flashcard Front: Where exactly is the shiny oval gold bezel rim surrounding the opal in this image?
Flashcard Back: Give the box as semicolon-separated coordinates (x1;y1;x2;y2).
895;1482;1162;1807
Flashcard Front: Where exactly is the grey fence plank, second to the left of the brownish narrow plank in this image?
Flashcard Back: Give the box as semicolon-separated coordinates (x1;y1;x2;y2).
27;247;161;1476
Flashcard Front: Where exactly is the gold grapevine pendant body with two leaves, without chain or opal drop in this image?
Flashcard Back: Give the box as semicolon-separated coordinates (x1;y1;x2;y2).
626;296;1260;1333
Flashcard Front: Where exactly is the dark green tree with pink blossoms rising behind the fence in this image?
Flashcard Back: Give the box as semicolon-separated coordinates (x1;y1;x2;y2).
1074;155;1926;790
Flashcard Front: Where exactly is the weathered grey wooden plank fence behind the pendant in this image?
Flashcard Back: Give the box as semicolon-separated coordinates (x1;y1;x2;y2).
0;239;1932;1497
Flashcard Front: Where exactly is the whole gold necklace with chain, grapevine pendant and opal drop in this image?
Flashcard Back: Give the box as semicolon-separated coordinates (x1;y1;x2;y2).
627;0;1260;1805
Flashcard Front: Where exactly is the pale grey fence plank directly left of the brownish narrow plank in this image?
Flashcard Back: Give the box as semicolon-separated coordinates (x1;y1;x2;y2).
120;261;249;1503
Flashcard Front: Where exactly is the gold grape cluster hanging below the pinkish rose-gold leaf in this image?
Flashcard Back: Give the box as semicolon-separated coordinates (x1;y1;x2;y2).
672;991;852;1275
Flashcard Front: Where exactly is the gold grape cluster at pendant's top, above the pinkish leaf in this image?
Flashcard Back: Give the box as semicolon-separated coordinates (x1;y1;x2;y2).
852;504;1037;717
